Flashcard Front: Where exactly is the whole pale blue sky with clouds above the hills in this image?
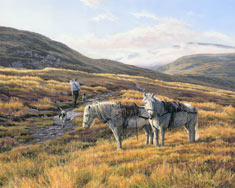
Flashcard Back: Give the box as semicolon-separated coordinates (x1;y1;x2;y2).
0;0;235;67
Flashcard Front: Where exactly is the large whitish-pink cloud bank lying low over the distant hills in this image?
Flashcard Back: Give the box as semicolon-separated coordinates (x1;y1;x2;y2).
58;14;235;67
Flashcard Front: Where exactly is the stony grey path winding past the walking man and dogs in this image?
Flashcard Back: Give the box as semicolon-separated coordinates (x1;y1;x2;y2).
27;92;114;144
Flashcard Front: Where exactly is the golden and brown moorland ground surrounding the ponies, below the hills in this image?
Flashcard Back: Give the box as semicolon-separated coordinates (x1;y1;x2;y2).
0;68;235;188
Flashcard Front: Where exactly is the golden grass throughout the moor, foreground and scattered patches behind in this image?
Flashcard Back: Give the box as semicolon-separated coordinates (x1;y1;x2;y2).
0;68;235;188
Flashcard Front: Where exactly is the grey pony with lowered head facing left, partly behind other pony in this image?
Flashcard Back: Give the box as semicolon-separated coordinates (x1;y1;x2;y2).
82;102;153;148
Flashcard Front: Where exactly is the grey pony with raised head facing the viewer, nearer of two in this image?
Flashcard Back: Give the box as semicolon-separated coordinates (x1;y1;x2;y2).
143;93;199;146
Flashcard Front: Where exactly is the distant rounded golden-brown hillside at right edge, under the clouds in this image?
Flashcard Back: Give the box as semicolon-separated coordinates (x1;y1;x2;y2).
157;53;235;89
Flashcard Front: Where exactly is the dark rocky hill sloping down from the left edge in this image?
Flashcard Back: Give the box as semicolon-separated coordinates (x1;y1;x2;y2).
0;27;175;80
